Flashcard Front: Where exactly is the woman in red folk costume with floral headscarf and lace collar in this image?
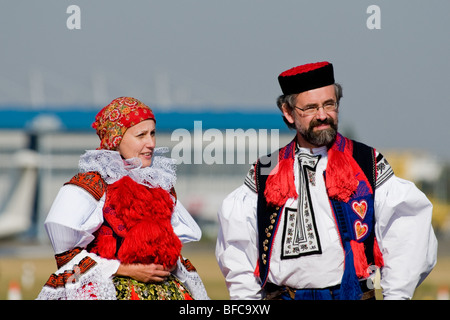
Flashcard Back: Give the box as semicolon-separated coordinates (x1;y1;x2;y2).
38;97;208;300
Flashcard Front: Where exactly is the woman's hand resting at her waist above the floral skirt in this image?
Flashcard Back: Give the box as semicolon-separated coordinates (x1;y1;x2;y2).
114;263;176;283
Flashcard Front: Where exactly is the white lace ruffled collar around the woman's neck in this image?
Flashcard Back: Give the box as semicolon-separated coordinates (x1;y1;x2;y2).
79;147;177;191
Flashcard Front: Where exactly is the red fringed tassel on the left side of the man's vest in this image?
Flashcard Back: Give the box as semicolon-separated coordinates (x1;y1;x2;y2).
264;157;298;206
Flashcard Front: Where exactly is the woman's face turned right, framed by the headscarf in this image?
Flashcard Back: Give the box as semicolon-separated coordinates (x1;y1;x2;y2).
117;119;156;168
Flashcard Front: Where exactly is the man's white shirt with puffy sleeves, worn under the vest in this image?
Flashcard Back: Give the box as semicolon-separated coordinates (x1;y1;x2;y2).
216;147;437;299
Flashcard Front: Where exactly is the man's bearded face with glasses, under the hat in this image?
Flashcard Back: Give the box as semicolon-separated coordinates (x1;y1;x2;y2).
283;85;338;148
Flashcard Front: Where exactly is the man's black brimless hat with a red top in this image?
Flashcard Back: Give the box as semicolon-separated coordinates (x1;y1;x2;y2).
278;61;334;95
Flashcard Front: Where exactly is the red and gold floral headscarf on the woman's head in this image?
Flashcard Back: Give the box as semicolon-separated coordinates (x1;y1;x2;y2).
92;97;156;150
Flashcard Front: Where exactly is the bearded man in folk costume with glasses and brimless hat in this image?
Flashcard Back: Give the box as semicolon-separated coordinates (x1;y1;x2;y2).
216;62;437;300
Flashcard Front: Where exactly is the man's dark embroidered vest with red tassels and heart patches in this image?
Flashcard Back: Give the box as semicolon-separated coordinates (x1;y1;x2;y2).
255;134;383;299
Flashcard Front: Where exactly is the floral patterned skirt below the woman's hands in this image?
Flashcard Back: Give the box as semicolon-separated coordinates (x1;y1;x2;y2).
113;275;193;300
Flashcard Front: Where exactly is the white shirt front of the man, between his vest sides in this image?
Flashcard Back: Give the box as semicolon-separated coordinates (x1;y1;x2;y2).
267;150;344;288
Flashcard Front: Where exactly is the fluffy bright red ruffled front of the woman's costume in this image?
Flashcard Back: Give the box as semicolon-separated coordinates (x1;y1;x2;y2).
91;177;182;268
